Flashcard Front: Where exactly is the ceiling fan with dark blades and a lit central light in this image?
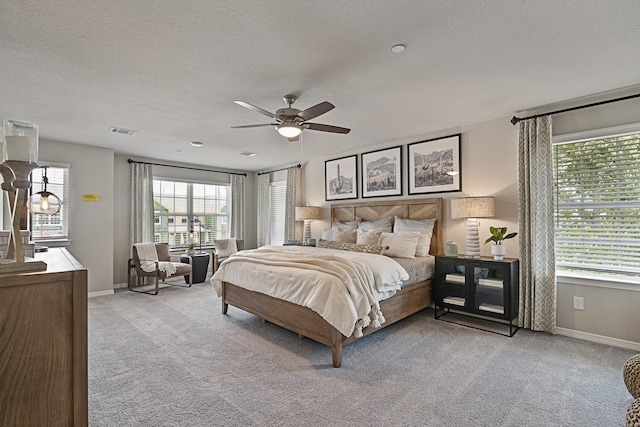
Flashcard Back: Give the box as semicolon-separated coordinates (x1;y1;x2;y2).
231;95;351;142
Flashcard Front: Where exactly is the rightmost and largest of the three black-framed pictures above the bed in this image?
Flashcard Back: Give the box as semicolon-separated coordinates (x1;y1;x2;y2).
407;134;462;194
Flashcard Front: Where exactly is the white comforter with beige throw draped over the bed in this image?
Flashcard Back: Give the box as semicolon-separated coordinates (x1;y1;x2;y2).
211;246;409;337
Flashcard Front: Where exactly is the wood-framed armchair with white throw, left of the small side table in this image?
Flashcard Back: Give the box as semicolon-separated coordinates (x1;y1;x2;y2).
127;243;193;295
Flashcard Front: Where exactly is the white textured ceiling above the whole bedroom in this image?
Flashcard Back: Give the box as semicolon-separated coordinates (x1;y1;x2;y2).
0;0;640;170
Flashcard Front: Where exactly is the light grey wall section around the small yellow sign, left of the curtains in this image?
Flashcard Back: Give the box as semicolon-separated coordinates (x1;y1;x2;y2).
39;139;114;293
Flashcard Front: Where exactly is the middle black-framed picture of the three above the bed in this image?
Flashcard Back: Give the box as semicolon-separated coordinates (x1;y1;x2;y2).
360;146;402;198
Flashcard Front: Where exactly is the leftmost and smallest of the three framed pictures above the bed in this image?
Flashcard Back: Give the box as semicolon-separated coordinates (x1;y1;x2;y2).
324;154;358;201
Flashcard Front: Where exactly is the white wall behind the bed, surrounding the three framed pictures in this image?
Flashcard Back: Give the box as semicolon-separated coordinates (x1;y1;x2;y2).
303;117;518;257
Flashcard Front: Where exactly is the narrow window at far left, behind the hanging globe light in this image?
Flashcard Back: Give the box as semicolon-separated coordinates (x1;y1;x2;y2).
29;162;70;243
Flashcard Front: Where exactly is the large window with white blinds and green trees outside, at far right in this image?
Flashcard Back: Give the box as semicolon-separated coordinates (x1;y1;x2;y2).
553;127;640;281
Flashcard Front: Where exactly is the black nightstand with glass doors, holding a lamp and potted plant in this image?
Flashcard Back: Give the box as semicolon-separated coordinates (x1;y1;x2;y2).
435;256;519;337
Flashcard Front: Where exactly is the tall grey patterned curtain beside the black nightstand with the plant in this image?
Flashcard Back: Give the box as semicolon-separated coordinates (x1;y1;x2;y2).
518;116;556;333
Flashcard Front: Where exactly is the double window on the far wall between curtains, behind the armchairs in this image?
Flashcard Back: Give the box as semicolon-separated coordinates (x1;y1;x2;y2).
153;179;231;246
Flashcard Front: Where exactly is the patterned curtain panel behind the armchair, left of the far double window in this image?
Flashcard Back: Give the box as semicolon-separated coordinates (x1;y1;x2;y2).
129;163;155;248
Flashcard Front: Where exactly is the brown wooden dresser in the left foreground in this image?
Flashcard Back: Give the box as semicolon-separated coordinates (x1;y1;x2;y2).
0;248;88;426
